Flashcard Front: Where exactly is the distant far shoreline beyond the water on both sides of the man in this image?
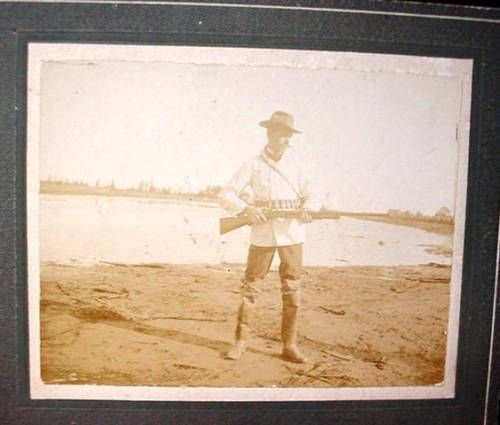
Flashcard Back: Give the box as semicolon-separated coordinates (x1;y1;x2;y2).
40;182;454;236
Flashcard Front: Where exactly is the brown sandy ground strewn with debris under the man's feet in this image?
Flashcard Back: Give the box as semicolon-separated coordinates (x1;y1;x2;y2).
41;263;451;387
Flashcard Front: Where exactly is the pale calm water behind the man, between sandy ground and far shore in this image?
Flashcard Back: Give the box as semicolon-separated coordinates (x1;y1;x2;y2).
40;194;451;266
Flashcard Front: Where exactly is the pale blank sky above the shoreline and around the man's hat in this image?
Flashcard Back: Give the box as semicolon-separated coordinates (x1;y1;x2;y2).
39;48;468;214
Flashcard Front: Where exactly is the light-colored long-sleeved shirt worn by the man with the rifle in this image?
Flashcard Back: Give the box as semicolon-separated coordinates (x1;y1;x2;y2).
219;150;321;246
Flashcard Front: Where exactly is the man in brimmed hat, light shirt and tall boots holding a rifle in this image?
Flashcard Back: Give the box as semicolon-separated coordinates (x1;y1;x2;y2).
220;111;320;363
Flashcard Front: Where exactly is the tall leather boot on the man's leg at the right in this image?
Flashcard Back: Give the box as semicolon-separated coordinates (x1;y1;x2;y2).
281;291;307;363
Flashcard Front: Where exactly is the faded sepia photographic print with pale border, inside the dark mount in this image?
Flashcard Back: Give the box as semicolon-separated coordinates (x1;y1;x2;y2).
27;43;472;400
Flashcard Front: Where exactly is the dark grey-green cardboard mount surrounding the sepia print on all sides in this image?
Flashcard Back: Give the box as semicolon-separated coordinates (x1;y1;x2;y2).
0;4;498;424
